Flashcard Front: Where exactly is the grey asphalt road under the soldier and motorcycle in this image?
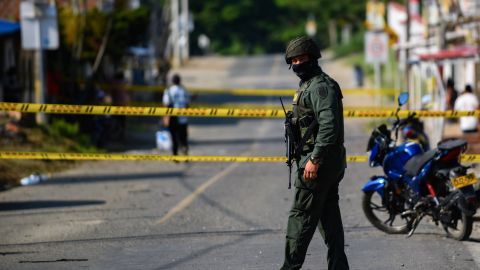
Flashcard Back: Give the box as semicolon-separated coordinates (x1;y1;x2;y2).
0;53;480;269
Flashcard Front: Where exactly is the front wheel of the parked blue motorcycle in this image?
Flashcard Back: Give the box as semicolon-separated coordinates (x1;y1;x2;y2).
362;191;412;234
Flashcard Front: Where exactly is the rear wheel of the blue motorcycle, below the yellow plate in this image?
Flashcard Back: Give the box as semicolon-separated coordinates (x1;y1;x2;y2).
442;206;473;241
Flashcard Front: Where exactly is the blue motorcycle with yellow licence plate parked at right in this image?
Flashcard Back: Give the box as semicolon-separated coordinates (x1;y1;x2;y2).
362;93;479;240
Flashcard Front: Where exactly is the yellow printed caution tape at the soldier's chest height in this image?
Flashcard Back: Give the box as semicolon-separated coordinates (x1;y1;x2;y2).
0;102;480;118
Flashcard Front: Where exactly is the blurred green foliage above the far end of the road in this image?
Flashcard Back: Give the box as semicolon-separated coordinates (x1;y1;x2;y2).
190;0;366;54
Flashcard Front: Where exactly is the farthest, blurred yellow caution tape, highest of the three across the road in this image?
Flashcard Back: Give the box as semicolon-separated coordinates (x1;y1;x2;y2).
125;85;400;96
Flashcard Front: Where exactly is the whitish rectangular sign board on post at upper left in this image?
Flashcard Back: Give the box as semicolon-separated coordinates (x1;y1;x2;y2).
20;1;59;50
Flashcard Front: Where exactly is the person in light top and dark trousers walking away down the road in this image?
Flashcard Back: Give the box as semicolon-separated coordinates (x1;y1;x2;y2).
163;74;190;155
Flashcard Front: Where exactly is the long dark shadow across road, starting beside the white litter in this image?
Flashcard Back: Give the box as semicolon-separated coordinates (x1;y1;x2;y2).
43;171;184;185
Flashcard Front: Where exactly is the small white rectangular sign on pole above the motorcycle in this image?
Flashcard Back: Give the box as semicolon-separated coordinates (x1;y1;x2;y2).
365;31;388;64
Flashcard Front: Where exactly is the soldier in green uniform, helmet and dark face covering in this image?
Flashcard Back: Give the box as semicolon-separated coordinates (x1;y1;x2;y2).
281;37;349;270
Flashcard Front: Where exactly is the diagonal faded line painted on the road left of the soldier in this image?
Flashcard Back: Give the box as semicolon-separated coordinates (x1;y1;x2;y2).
155;163;240;225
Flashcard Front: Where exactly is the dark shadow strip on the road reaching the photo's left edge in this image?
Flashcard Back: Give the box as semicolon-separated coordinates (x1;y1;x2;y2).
0;200;105;211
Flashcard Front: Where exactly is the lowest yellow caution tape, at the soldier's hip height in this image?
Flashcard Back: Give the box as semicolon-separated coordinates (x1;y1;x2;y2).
0;151;480;163
